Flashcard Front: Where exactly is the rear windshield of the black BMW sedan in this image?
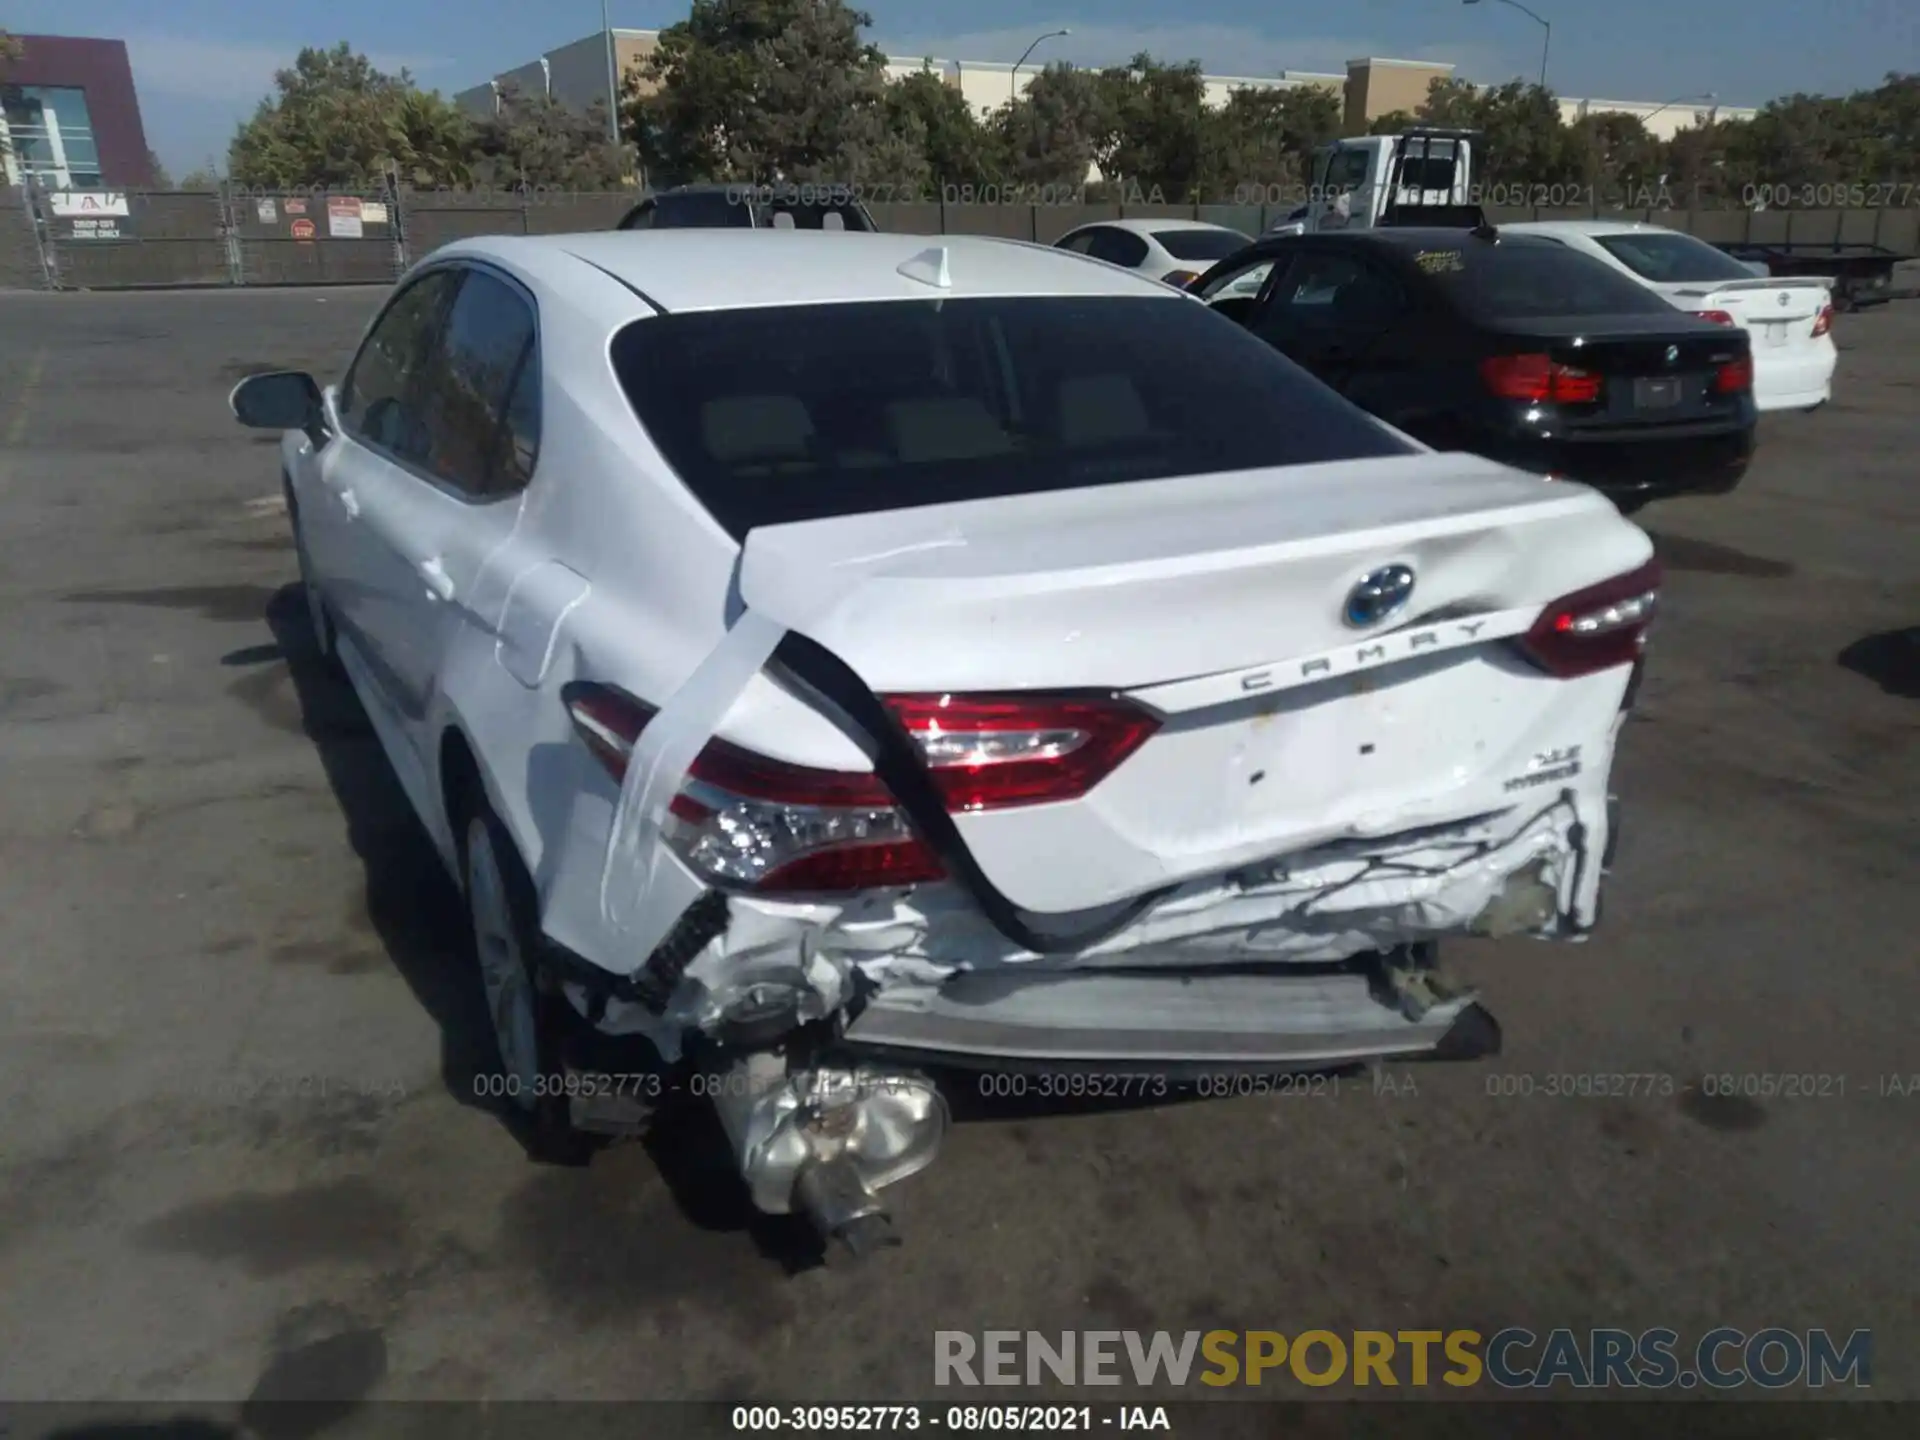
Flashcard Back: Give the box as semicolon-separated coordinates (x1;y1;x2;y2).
1415;236;1672;321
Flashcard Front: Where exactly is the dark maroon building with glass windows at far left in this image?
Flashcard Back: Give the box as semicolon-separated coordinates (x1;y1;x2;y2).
0;35;154;190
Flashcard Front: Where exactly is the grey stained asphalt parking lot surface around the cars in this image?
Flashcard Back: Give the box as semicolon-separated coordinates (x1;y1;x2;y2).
0;290;1920;1402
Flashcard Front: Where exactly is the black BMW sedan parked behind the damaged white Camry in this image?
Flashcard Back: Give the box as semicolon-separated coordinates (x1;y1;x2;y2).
1188;228;1757;509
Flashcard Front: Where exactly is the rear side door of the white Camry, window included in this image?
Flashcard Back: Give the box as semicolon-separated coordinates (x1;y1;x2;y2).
341;263;541;762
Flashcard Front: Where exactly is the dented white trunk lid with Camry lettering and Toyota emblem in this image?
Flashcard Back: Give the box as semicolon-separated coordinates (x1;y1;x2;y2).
739;453;1651;912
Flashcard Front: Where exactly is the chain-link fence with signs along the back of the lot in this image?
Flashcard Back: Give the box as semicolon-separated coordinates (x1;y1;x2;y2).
0;184;1920;290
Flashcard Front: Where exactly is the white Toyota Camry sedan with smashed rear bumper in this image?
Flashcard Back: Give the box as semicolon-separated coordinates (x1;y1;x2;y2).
232;230;1659;1248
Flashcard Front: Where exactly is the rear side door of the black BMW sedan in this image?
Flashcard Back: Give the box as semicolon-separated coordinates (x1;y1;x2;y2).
1248;248;1405;390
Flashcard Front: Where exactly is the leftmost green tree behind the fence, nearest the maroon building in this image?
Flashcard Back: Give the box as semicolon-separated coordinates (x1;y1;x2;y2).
227;40;474;188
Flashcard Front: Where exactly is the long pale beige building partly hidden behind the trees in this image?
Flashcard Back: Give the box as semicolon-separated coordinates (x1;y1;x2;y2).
453;29;1755;140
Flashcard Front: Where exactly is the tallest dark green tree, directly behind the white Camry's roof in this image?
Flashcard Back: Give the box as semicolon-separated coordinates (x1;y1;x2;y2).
624;0;902;184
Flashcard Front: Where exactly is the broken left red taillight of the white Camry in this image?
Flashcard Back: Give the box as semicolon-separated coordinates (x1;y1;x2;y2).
566;684;1158;895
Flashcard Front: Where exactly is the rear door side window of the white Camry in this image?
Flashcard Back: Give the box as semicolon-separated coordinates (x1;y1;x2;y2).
420;269;540;499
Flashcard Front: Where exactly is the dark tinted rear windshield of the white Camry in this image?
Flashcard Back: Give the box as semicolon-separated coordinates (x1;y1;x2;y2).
612;296;1413;540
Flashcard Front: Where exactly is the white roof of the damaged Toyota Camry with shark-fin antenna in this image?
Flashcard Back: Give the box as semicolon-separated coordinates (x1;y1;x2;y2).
434;227;1185;311
